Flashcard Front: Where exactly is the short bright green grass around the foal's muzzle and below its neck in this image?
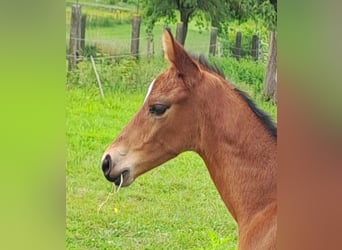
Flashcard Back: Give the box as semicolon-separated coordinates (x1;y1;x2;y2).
66;85;237;249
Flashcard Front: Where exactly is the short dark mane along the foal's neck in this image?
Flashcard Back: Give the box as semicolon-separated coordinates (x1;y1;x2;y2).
191;55;277;140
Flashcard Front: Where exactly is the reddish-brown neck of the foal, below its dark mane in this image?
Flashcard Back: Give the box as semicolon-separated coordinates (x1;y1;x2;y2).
197;79;276;226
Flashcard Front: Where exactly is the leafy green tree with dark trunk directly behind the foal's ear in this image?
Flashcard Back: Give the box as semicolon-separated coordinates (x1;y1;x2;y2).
142;0;231;45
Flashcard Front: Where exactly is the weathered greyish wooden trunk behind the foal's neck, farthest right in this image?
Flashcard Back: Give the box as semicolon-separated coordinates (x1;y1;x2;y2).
264;31;277;103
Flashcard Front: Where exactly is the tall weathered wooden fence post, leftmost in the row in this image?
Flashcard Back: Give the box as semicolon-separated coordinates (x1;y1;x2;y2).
68;4;82;71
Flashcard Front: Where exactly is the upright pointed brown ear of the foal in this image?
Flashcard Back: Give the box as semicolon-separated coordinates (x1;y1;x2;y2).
163;29;200;80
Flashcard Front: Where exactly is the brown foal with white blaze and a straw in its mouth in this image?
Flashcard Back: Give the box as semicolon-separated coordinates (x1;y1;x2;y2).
102;30;277;250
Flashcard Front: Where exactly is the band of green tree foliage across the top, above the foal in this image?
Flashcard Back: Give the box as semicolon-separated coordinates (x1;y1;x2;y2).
141;0;276;44
